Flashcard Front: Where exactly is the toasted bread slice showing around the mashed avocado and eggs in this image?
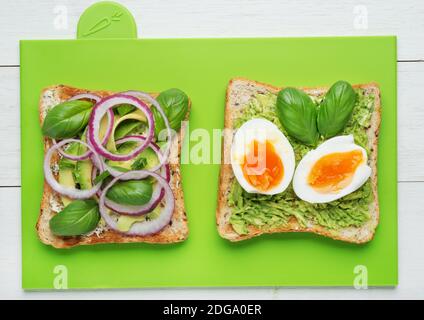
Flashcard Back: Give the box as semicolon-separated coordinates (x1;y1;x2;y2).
216;78;381;243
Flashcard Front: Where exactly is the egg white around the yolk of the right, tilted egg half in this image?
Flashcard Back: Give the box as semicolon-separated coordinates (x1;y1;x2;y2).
293;135;371;203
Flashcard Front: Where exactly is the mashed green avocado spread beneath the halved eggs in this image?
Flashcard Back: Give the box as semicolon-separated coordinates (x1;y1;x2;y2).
227;89;374;234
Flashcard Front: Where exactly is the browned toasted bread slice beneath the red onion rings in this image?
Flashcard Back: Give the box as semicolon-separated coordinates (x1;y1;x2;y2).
36;85;188;248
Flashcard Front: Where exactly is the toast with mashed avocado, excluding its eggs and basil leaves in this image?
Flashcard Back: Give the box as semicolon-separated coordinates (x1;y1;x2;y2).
216;78;381;243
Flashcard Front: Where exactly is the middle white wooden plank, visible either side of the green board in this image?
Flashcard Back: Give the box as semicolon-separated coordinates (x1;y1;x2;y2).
0;63;424;186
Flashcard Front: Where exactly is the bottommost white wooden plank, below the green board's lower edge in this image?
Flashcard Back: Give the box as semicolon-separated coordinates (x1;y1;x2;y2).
0;182;424;299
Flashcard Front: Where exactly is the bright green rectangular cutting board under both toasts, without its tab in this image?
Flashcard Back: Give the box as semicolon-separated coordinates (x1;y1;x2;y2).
20;1;398;289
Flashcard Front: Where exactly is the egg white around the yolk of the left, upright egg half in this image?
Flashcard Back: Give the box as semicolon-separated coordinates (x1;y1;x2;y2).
231;119;295;195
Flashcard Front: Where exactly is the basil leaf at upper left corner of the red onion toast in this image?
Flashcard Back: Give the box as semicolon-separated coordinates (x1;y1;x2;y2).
42;100;93;139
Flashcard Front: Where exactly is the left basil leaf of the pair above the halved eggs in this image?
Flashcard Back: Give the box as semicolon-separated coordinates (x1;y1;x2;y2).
277;88;319;146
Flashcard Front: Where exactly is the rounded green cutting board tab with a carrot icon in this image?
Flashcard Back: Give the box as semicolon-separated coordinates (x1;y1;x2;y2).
77;1;137;39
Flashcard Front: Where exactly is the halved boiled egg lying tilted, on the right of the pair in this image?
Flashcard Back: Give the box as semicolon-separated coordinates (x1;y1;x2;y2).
293;135;371;203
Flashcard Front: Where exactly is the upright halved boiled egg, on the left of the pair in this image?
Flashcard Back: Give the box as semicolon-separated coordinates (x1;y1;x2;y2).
231;119;295;195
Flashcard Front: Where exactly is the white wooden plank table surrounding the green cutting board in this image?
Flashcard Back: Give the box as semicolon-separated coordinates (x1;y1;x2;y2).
0;0;424;299
